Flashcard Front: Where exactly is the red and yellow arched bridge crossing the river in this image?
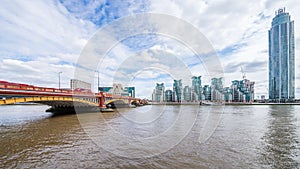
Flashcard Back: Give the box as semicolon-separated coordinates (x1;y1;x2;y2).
0;81;146;111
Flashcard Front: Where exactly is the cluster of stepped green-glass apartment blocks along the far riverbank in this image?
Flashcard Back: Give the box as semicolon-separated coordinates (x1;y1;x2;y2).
152;76;255;104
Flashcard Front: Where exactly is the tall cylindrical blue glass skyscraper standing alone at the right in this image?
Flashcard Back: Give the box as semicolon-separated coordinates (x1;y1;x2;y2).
269;9;295;102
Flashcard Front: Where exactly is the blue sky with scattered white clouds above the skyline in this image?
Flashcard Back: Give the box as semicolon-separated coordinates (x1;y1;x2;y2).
0;0;300;98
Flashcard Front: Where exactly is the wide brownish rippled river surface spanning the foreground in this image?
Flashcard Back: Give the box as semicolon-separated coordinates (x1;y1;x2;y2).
0;105;300;168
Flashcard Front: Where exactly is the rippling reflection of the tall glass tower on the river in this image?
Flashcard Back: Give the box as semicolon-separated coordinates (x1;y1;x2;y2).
262;106;300;168
